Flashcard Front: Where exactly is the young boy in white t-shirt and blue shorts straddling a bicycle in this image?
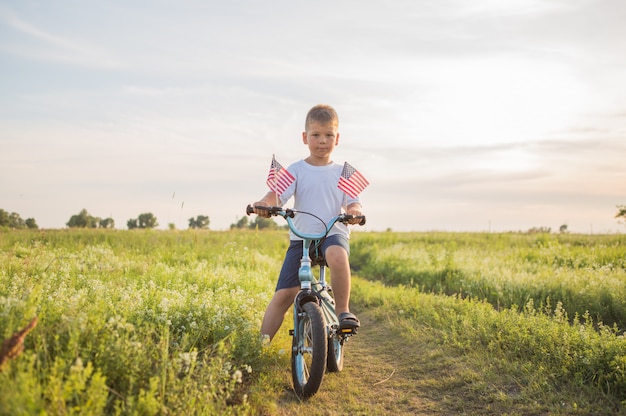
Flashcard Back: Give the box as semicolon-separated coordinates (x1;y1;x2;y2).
253;104;362;340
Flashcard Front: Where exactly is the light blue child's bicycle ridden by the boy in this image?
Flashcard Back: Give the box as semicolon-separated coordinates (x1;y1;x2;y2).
246;205;365;399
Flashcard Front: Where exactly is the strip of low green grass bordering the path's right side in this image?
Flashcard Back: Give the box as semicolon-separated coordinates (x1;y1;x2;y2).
353;281;626;408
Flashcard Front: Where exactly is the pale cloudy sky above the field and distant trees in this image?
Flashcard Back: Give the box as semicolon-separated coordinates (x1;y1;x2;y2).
0;0;626;233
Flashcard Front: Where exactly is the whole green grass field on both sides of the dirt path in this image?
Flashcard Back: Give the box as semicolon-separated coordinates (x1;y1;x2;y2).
0;230;626;415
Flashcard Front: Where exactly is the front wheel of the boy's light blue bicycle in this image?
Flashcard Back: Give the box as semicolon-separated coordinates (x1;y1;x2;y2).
291;302;328;399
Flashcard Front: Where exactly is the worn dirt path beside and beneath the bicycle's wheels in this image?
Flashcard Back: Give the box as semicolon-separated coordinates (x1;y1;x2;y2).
270;310;473;415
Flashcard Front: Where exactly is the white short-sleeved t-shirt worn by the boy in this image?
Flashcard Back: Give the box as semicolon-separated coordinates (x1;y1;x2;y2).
280;160;359;240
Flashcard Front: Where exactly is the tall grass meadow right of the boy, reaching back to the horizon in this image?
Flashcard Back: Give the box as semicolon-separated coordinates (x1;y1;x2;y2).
352;233;626;329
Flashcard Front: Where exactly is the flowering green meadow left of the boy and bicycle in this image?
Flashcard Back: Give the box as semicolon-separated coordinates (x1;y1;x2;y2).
0;230;285;414
